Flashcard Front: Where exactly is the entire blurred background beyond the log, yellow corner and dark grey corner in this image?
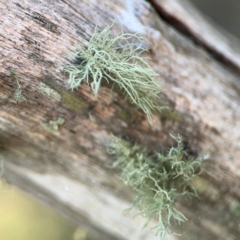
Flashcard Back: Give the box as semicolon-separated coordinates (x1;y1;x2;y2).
0;0;240;240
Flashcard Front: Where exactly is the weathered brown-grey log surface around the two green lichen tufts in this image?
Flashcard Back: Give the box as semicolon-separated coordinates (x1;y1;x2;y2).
0;0;240;240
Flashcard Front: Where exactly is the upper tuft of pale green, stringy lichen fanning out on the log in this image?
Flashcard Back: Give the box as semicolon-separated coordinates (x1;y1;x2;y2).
64;25;162;122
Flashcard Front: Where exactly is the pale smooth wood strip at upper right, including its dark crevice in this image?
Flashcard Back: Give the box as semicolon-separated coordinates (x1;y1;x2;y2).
150;0;240;72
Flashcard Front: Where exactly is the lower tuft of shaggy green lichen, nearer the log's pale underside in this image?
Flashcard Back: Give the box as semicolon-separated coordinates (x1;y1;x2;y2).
108;137;203;240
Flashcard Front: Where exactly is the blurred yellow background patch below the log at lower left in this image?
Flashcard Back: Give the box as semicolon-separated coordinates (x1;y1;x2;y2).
0;184;77;240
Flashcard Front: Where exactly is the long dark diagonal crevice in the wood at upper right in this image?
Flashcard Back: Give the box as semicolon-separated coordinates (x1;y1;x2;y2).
148;0;240;74
